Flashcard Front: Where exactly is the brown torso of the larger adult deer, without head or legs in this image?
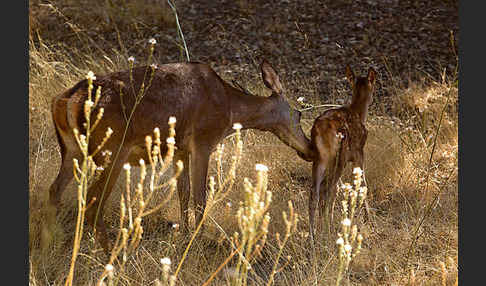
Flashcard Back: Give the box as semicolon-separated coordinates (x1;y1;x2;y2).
53;63;234;152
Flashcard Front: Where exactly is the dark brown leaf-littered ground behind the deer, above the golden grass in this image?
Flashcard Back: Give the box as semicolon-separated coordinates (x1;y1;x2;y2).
30;0;459;106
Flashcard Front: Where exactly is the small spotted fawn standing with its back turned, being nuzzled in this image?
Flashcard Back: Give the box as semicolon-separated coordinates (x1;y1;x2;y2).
309;66;376;242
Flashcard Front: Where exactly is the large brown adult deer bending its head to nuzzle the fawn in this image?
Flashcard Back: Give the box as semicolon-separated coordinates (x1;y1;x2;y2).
49;61;312;252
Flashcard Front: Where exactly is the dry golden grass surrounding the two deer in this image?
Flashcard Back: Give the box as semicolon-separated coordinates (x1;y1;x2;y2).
29;1;458;285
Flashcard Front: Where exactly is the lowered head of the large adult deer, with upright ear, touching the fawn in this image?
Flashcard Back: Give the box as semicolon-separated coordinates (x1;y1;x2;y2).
260;60;310;161
